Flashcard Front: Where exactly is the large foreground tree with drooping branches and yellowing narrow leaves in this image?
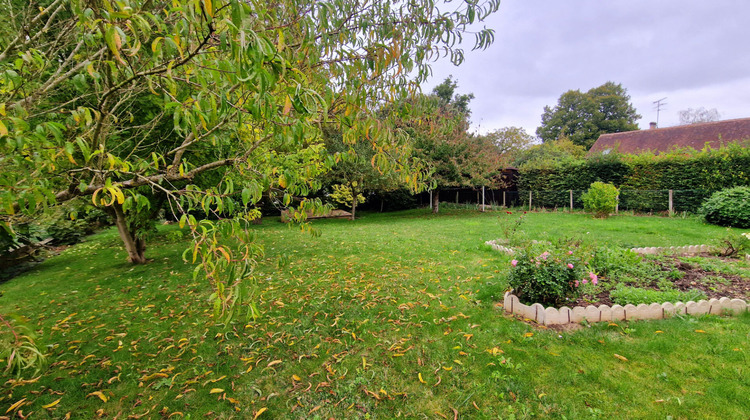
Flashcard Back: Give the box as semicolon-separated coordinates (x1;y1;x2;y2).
0;0;506;312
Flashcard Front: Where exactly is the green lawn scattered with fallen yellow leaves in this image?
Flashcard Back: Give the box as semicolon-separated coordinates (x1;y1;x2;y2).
0;210;750;419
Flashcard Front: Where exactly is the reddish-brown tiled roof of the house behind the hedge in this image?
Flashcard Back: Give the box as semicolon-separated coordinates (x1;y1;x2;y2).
588;118;750;156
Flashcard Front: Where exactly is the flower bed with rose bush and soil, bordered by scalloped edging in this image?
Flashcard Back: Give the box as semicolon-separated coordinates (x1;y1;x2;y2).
487;241;750;325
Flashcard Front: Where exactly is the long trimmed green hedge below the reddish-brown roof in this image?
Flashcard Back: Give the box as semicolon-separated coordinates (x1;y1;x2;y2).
518;142;750;212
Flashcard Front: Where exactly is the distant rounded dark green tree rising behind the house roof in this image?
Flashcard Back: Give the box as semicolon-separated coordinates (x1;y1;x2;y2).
536;82;641;150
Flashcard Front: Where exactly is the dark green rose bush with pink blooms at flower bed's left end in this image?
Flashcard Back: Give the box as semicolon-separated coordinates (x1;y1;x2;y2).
508;244;597;305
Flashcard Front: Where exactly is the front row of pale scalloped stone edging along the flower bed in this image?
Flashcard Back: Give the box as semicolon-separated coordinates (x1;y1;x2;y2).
503;292;750;325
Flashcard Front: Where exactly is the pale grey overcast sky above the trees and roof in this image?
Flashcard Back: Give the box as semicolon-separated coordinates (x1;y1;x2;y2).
423;0;750;135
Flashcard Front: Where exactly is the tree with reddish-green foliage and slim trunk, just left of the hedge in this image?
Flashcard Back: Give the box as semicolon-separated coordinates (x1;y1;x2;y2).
405;77;500;213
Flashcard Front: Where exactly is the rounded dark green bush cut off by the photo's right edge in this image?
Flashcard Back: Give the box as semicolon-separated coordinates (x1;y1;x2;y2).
699;187;750;229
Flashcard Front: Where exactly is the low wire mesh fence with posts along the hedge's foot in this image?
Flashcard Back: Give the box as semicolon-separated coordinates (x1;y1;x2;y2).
420;188;714;213
